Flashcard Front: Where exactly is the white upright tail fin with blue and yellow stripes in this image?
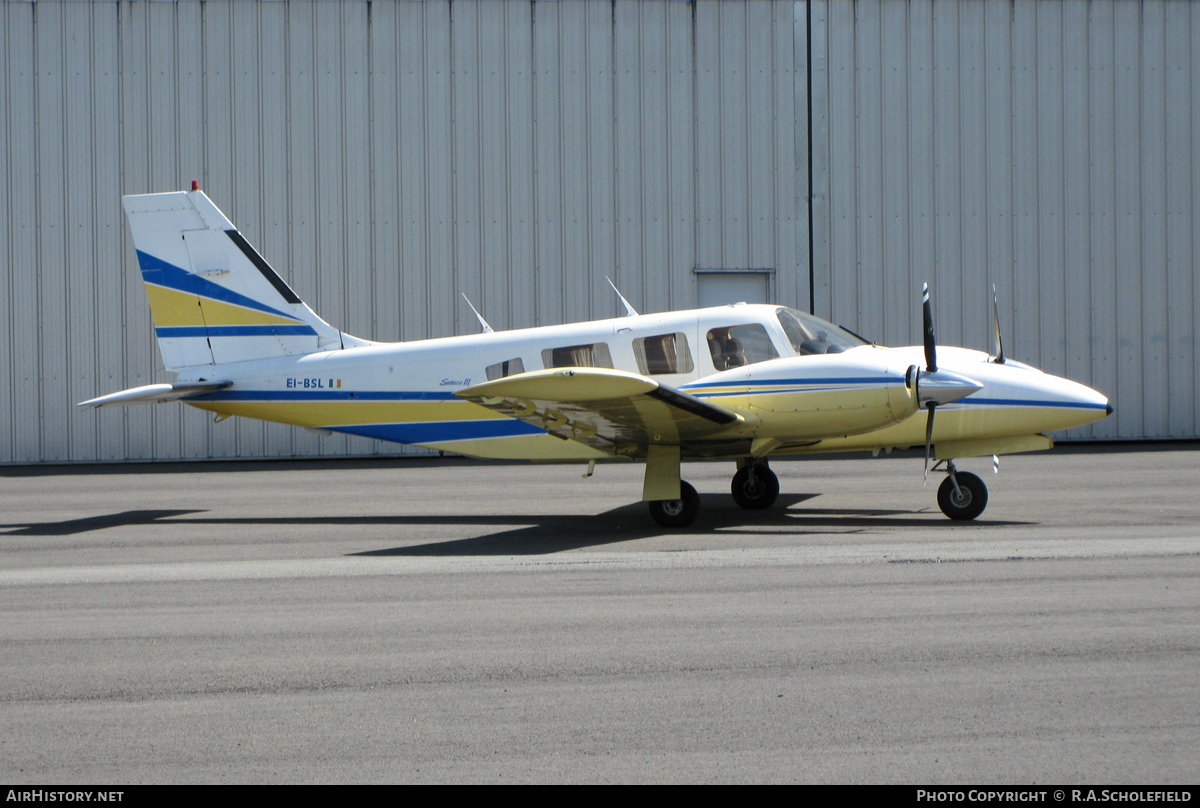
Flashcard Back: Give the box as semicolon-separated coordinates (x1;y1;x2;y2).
124;184;370;371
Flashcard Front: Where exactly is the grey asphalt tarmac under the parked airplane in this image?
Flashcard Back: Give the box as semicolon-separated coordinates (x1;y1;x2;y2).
0;443;1200;785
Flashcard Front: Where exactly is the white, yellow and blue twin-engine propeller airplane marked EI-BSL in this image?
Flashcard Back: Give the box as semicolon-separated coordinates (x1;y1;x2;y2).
79;189;1112;527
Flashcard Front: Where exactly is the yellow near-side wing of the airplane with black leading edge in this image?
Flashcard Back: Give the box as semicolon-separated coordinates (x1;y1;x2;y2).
455;367;745;455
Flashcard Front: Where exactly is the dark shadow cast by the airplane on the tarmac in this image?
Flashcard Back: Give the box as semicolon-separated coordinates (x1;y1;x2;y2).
0;493;1030;556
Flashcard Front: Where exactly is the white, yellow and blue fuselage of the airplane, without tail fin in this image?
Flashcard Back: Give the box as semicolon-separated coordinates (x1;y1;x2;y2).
180;304;1108;460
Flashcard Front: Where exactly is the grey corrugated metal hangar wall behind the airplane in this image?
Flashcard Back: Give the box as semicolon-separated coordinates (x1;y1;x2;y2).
0;0;1200;462
